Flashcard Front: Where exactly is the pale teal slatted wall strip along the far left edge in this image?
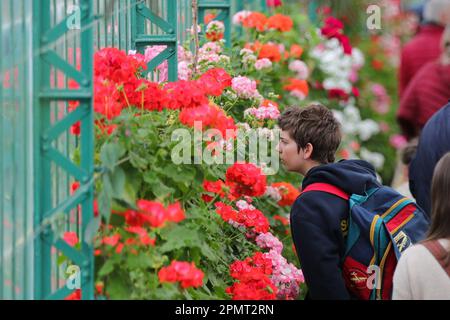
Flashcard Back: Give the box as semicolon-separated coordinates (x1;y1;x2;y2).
0;0;33;300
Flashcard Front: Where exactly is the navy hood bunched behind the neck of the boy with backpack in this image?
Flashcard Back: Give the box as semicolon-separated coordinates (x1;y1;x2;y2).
302;160;380;194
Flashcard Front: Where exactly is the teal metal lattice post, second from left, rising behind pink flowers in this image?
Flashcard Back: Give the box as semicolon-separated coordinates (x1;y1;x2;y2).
131;0;178;81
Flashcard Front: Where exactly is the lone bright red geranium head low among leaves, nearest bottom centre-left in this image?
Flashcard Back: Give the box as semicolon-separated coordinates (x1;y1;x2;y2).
158;260;205;289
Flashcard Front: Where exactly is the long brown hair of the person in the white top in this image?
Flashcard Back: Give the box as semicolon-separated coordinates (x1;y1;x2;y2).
428;152;450;265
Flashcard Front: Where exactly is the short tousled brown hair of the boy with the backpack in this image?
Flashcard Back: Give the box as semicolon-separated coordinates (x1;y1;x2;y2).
278;104;342;163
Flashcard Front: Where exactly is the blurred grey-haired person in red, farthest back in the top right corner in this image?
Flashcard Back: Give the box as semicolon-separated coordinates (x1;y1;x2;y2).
399;0;450;98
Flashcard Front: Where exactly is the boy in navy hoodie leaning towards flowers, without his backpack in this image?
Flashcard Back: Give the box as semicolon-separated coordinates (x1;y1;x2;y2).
278;104;379;299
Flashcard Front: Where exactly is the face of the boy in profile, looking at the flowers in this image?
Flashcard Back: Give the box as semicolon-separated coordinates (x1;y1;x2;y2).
278;130;305;173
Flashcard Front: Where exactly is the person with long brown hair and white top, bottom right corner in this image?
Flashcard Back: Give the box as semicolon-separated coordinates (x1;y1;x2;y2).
392;152;450;300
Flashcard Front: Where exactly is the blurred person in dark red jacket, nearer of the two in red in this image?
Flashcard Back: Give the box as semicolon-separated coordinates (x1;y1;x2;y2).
397;24;450;139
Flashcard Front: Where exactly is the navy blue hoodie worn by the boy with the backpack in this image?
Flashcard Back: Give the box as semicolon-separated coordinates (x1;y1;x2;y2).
291;160;379;299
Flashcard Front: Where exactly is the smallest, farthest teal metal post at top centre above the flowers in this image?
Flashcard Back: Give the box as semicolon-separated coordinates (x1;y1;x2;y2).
198;0;231;48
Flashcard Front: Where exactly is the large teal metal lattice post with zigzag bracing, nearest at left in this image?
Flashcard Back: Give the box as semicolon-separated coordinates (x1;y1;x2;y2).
33;0;94;299
